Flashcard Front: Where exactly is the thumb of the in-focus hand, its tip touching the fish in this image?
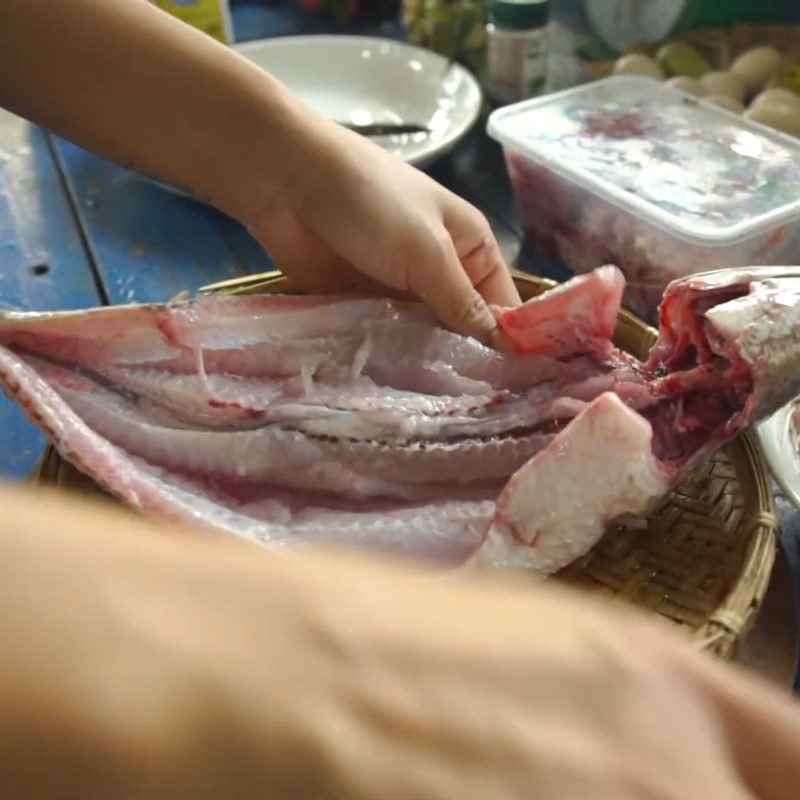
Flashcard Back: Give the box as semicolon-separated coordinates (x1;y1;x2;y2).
395;229;497;344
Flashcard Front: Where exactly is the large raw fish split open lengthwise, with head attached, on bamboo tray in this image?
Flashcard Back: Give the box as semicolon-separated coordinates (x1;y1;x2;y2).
0;266;800;574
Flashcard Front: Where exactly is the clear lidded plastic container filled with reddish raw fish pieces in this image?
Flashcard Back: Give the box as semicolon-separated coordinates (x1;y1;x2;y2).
488;76;800;320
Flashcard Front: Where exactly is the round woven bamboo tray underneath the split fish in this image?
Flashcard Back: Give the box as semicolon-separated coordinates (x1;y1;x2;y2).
31;272;778;659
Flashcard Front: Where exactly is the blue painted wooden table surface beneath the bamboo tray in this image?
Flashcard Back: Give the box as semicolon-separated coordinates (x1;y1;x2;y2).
0;0;800;684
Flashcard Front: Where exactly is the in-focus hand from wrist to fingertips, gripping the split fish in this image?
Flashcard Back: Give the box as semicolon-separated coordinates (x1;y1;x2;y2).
245;109;520;343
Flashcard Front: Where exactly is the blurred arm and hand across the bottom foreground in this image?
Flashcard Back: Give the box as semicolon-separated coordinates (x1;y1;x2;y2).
0;487;800;800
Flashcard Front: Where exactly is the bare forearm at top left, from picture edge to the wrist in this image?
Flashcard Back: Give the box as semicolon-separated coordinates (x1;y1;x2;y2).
0;0;304;218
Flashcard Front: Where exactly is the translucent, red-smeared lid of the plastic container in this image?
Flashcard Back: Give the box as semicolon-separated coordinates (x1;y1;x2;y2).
488;75;800;245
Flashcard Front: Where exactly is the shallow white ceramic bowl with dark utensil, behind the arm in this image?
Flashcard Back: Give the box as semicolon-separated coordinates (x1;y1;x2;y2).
233;36;481;166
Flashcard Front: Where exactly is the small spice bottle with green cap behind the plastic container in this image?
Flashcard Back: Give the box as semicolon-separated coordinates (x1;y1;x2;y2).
486;0;550;103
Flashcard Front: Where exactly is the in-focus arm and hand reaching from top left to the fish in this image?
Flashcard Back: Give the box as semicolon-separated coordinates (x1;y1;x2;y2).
0;0;519;342
